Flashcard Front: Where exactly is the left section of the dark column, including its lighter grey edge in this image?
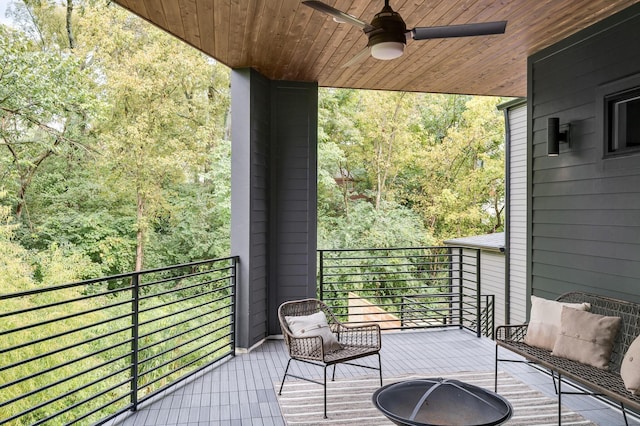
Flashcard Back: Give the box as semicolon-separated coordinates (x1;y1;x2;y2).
231;69;271;348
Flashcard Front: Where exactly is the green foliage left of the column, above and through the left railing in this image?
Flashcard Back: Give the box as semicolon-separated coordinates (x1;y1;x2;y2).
0;5;231;424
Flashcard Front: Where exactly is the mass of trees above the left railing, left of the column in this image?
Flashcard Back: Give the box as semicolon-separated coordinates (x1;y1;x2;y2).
0;0;230;279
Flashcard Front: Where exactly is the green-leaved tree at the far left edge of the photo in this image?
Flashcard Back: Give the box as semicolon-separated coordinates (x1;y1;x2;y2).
0;22;95;223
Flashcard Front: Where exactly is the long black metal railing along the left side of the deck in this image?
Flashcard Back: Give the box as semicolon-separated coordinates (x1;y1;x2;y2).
0;257;238;425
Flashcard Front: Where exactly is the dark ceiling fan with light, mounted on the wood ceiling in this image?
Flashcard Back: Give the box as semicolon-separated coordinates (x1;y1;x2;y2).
302;0;507;66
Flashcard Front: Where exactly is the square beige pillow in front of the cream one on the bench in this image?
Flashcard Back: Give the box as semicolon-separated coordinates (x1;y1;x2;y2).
551;306;622;370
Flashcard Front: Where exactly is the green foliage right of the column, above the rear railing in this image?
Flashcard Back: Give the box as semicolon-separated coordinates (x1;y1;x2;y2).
318;89;504;248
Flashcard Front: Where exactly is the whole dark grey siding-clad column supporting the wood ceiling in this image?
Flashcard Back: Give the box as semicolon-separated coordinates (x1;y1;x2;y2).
231;69;317;349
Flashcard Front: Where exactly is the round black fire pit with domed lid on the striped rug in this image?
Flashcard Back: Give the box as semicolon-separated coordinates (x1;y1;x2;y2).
373;378;513;426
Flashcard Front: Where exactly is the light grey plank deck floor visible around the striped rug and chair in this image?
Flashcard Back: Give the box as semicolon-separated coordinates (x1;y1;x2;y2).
107;329;640;426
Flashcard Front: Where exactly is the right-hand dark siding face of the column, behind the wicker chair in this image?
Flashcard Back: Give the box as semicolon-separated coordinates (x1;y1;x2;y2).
270;82;318;334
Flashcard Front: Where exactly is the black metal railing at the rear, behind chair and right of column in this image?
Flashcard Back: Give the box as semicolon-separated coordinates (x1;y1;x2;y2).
318;247;493;336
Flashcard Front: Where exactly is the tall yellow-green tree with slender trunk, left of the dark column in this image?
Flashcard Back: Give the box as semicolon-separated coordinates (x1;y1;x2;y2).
67;2;228;270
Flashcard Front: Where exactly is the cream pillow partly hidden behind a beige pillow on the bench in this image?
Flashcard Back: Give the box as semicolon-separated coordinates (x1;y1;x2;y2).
524;296;591;351
